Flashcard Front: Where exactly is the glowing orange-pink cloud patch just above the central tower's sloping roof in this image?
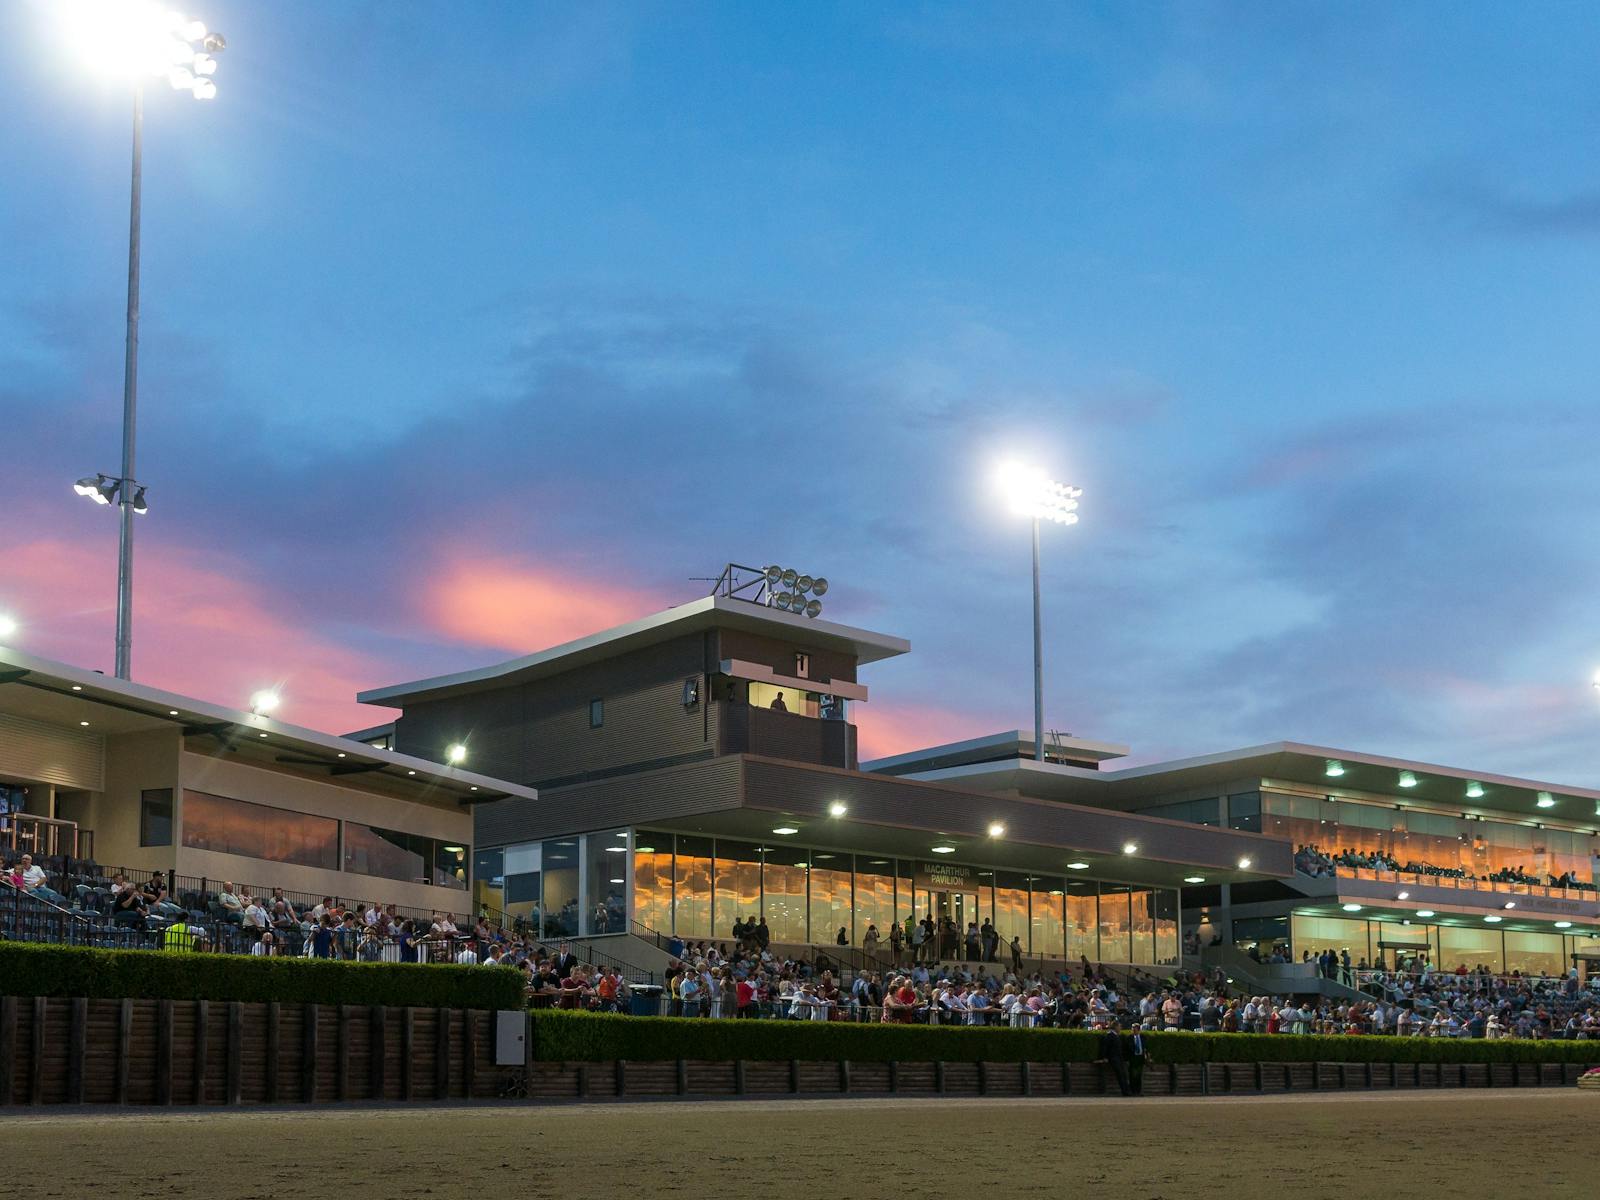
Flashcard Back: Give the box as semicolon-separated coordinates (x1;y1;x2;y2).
422;557;661;654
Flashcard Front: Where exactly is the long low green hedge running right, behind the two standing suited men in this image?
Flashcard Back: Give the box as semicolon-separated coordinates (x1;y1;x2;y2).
531;1010;1600;1064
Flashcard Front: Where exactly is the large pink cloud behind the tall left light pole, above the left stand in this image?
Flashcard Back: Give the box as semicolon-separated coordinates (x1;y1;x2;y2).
0;536;390;733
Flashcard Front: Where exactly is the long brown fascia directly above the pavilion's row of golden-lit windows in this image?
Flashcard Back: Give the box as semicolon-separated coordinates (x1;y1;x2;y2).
744;758;1293;875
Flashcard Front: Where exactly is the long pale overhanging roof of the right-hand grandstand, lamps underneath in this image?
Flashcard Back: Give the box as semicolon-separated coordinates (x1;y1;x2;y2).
912;742;1600;829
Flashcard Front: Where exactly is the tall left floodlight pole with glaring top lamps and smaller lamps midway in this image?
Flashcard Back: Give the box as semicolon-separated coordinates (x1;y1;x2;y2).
61;0;227;678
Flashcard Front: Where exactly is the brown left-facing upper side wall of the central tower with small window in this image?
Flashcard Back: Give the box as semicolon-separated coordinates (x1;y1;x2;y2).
395;634;717;787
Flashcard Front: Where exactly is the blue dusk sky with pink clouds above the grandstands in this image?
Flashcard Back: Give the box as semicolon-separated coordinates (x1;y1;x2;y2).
0;2;1600;784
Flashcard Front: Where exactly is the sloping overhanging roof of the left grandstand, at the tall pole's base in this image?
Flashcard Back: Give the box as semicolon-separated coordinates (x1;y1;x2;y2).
0;646;539;803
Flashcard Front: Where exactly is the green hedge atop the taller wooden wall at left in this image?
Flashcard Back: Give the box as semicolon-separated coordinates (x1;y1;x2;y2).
0;942;523;1008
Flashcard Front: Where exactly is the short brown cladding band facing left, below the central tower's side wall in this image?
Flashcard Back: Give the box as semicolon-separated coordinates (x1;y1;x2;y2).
474;758;742;848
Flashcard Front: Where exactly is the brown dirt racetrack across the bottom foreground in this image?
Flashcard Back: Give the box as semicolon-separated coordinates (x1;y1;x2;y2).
0;1088;1600;1200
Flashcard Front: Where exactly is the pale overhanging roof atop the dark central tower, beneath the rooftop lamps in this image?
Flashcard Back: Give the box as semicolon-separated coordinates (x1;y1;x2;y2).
357;595;910;707
